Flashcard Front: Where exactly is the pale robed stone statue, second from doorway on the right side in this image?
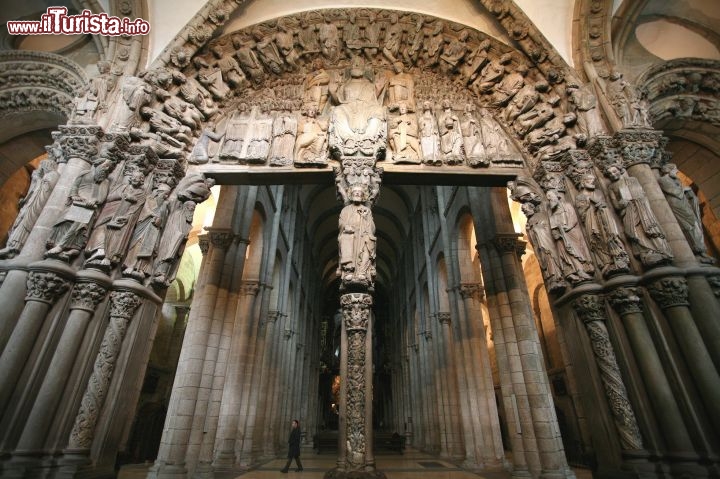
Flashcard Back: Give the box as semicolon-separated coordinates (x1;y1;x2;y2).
546;190;595;284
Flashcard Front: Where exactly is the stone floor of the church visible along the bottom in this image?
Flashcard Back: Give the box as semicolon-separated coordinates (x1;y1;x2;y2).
118;450;592;479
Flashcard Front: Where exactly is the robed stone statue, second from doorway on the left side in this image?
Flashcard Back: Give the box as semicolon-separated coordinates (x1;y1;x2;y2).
123;183;170;281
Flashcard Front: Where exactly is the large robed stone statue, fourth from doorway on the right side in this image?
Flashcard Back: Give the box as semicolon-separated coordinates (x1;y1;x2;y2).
605;164;673;267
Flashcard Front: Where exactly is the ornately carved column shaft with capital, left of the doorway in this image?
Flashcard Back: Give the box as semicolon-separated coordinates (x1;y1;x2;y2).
65;289;143;462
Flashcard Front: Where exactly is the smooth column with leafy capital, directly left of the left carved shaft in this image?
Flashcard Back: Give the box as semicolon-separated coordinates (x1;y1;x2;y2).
16;269;111;452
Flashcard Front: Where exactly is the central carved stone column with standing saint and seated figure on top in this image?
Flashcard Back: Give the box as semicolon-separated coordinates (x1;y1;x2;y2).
325;59;387;479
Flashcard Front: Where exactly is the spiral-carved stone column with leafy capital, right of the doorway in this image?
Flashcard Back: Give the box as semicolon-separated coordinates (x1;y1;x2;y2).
572;294;643;451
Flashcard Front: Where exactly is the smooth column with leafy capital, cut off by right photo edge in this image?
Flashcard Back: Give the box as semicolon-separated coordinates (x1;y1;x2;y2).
647;276;720;430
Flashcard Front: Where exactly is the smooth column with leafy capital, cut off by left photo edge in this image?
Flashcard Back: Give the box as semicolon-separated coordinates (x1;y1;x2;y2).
0;260;75;413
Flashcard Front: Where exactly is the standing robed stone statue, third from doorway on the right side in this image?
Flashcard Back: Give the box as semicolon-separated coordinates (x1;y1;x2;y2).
575;172;630;278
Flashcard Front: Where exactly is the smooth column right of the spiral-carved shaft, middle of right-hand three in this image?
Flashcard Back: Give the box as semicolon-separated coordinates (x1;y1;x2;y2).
608;288;693;458
